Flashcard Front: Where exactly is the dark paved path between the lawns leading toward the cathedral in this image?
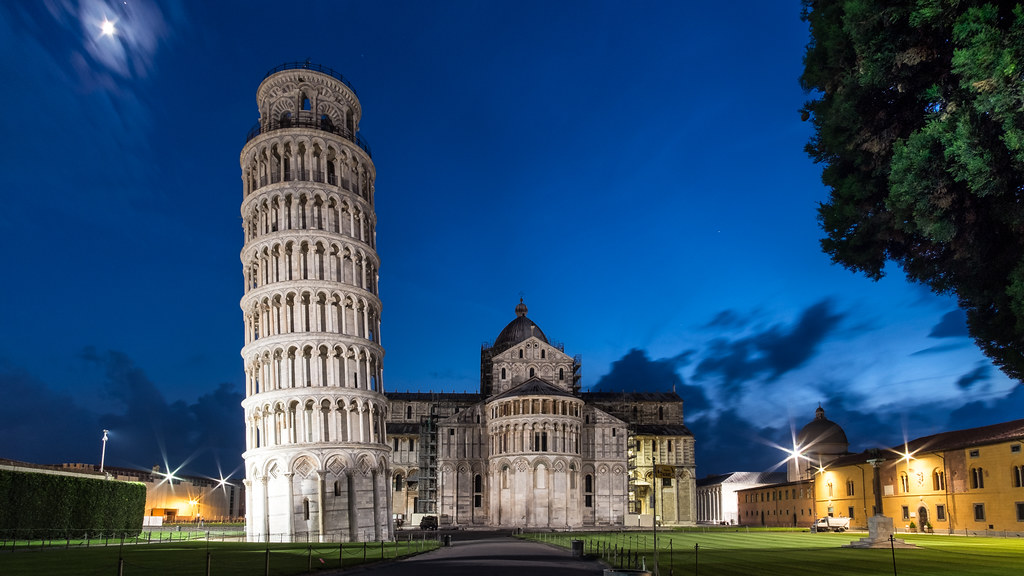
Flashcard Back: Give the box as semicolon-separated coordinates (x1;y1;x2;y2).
333;534;605;576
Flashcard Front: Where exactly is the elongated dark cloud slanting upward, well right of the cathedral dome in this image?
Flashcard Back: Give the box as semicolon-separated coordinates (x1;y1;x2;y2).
693;300;845;394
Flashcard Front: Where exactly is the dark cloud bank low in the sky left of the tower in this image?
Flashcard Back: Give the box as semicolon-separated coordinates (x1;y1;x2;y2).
0;347;245;477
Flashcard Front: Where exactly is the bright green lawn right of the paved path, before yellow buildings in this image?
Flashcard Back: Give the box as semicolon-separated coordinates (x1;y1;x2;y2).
526;529;1024;576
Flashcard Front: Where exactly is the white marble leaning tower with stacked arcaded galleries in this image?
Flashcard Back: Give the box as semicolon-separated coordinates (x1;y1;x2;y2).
241;63;392;541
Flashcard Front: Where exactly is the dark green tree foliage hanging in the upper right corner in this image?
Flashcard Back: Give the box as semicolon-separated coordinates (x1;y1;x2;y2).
801;0;1024;380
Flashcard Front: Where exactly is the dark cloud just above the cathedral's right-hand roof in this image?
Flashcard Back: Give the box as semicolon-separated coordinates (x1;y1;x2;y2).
591;348;710;412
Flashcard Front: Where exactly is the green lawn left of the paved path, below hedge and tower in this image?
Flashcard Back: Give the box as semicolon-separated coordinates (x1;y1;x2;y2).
0;540;437;576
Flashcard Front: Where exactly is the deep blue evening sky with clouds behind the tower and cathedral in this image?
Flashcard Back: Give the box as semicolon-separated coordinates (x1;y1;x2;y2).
0;0;1024;477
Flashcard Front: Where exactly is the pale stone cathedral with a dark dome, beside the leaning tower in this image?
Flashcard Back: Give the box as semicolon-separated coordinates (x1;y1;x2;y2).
387;301;695;529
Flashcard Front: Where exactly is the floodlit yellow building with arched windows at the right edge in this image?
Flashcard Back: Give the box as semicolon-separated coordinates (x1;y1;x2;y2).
814;419;1024;534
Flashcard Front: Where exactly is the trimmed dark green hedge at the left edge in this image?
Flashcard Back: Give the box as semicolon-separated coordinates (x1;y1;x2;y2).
0;469;145;539
